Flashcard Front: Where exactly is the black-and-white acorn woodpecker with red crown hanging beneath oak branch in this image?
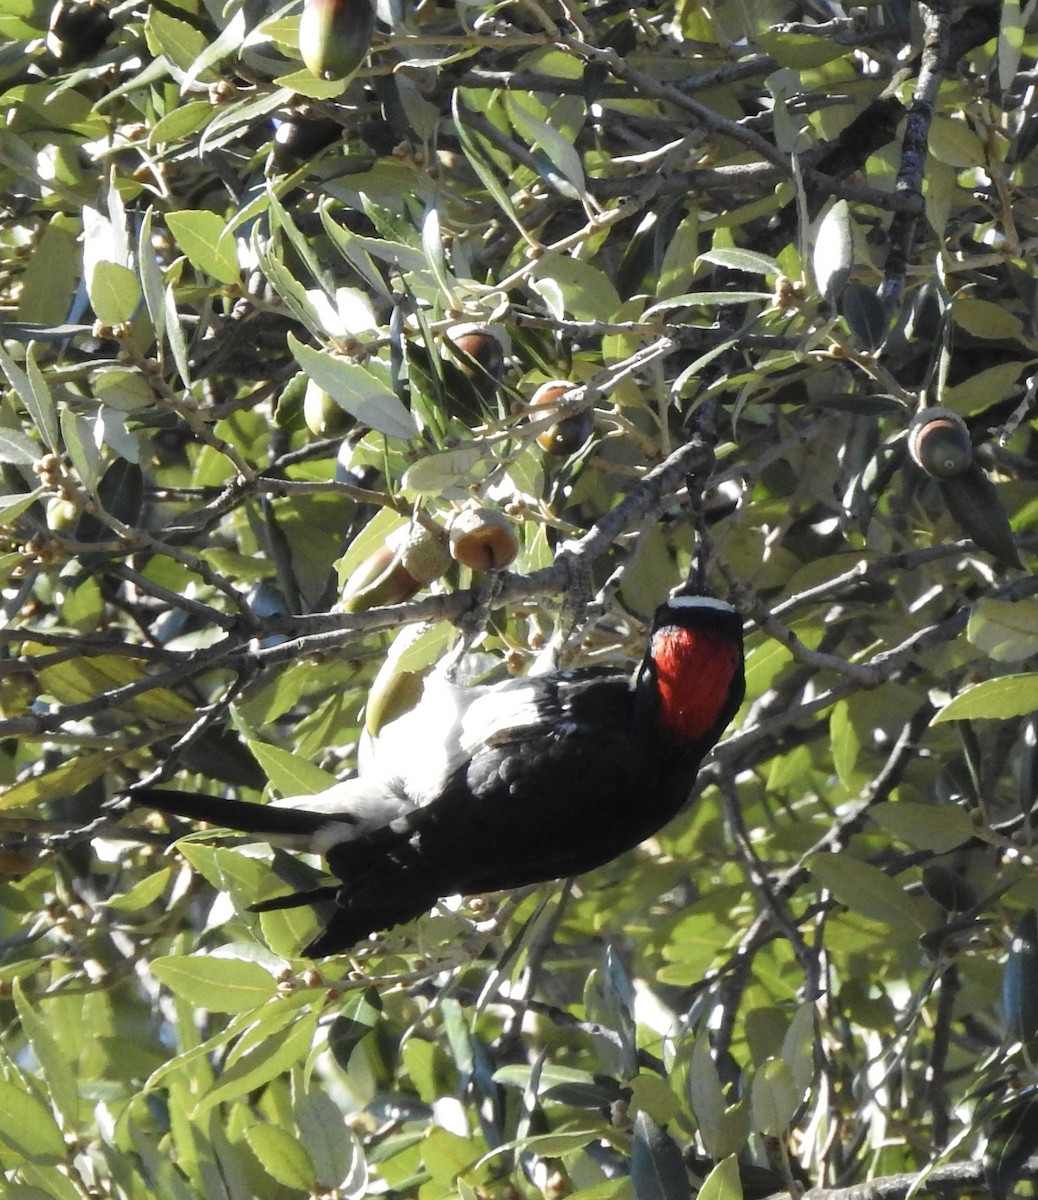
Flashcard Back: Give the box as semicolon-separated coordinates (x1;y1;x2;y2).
130;589;745;958
